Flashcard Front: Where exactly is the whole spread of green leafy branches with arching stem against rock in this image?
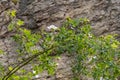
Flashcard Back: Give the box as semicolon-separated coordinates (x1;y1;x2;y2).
0;11;120;80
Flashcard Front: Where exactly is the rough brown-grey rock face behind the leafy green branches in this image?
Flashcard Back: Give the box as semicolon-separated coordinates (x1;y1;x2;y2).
0;0;120;80
